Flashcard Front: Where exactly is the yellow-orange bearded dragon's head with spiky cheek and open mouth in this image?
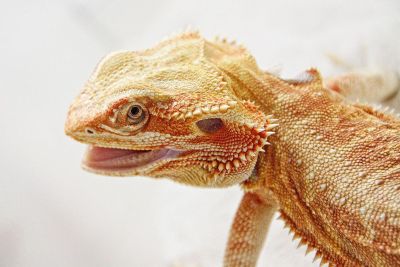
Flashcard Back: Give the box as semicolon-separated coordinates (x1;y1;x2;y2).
65;33;275;187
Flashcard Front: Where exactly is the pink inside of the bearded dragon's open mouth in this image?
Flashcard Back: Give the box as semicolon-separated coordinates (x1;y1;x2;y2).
83;146;179;171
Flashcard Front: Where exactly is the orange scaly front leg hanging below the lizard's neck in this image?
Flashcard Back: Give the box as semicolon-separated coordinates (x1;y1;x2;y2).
224;192;276;267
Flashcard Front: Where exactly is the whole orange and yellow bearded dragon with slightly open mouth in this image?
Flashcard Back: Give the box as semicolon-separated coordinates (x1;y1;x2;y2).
65;32;400;267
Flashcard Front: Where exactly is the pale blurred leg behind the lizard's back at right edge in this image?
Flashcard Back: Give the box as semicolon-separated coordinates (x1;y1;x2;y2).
326;71;400;102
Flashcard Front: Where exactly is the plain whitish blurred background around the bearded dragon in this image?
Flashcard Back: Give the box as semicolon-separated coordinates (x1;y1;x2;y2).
0;0;400;267
